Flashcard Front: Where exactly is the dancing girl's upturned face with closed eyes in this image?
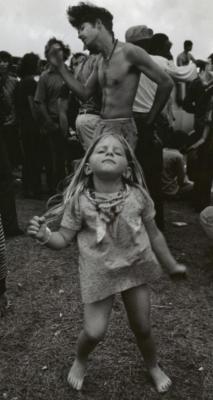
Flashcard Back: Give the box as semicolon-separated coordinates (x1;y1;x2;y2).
88;136;128;179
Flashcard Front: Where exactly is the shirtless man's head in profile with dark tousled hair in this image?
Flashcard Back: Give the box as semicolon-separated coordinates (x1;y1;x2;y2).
67;2;114;48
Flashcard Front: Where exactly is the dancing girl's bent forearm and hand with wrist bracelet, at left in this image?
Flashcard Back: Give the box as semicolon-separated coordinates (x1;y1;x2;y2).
27;216;76;250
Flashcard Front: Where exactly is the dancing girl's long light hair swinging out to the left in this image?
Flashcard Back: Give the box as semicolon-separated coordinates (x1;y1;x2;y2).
44;133;148;222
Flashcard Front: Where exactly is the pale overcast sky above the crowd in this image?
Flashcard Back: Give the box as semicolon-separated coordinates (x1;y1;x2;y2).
0;0;213;59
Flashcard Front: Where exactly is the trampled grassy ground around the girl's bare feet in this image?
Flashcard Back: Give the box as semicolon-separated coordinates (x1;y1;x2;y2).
0;198;213;400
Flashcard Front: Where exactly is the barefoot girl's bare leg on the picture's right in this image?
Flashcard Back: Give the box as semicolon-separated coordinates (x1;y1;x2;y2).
122;285;171;393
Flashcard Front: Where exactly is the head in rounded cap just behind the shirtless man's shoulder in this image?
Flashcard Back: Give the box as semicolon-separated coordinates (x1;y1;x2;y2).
125;25;153;52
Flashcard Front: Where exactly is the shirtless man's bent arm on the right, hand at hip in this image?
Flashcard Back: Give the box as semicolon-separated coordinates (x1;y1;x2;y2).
126;44;174;125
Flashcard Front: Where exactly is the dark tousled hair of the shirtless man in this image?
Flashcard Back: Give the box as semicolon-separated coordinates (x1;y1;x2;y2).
67;2;113;35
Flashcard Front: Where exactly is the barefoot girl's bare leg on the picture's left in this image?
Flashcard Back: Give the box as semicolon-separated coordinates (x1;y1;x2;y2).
68;296;114;390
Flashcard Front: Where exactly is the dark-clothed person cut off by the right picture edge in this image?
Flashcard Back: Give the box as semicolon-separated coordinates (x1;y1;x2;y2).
183;54;213;212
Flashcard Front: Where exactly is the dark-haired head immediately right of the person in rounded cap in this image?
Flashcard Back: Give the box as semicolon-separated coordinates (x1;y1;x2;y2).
150;33;172;59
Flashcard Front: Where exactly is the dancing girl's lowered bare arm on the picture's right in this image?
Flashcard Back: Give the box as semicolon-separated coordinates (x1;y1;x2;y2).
144;219;186;275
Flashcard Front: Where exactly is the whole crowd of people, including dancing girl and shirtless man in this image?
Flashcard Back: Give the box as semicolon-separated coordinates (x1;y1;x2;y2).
0;3;213;392
